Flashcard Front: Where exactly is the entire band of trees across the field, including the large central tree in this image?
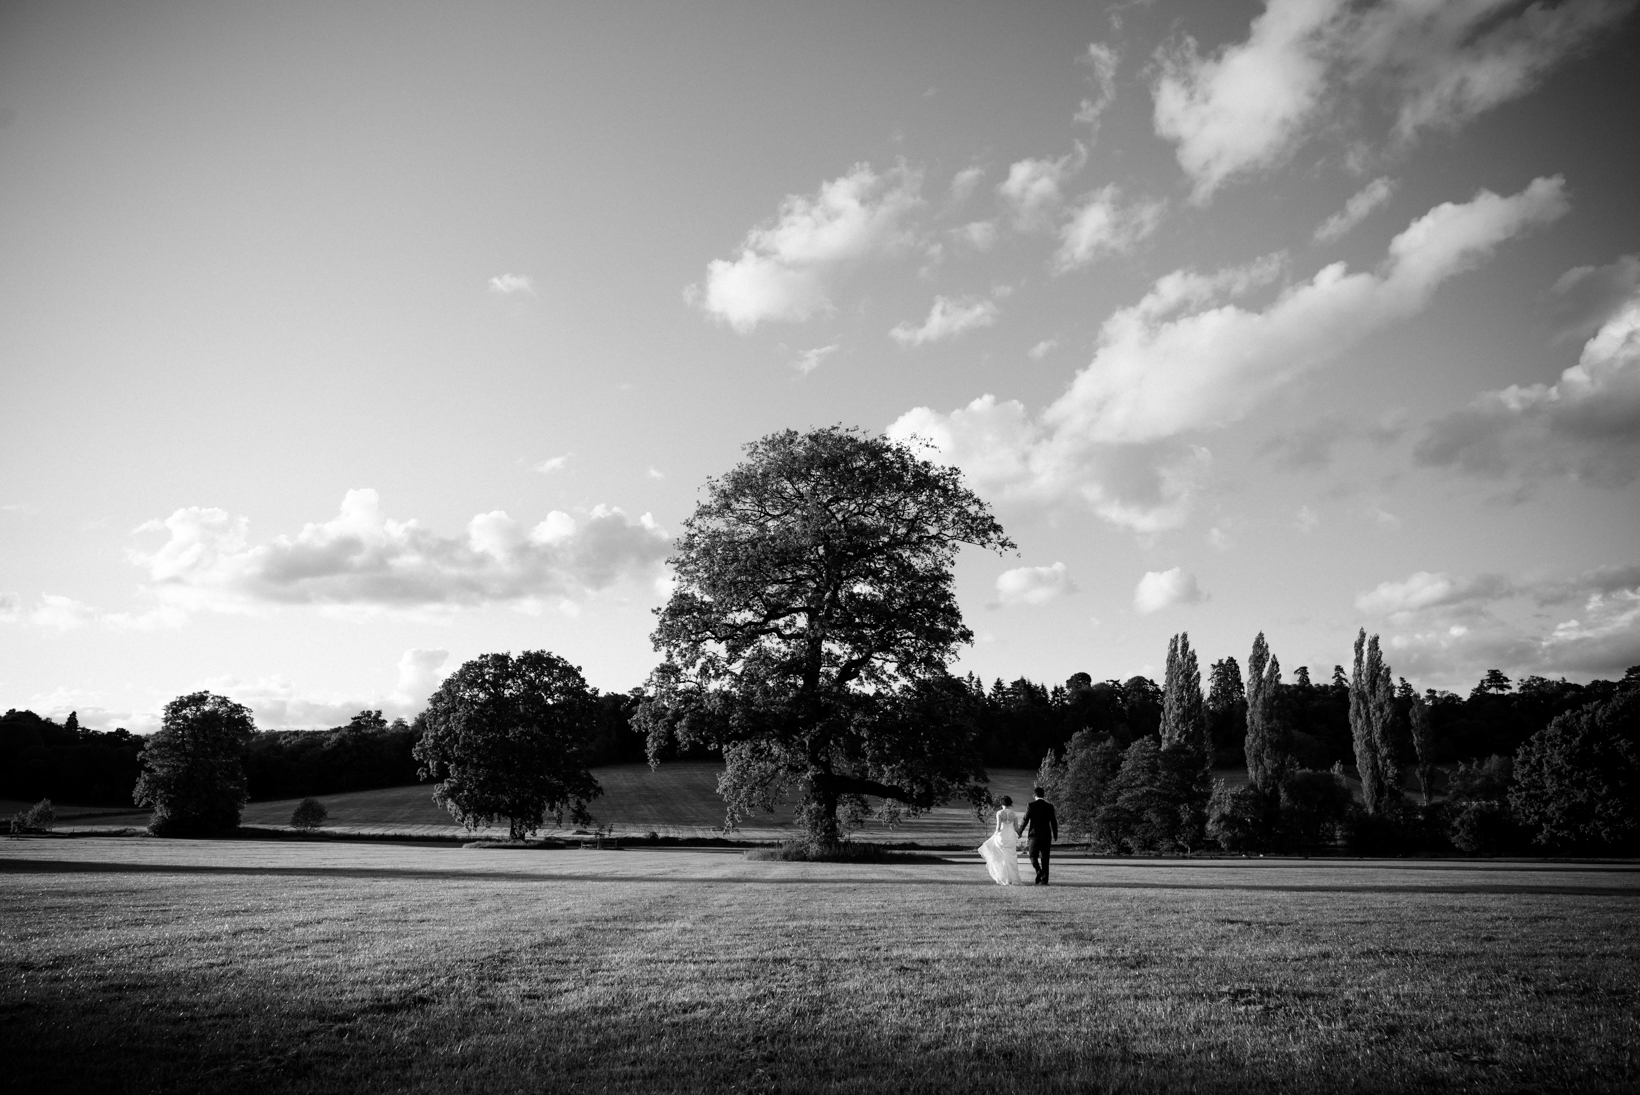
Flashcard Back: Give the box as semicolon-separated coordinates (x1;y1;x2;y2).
0;426;1640;856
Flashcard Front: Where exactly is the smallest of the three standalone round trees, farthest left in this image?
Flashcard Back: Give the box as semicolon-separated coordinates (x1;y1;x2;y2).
131;692;256;836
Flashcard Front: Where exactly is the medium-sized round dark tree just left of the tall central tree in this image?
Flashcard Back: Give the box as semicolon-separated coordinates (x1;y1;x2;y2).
415;651;604;841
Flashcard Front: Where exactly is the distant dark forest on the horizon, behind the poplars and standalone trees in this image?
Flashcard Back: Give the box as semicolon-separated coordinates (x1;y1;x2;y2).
0;657;1637;806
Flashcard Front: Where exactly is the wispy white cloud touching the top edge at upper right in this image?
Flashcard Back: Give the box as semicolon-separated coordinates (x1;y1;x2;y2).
1153;0;1633;202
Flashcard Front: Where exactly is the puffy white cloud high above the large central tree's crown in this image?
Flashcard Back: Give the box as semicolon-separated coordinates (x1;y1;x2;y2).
689;164;922;334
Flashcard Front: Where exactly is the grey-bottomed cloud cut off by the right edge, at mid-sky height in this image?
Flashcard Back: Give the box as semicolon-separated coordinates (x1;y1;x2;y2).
1412;281;1640;487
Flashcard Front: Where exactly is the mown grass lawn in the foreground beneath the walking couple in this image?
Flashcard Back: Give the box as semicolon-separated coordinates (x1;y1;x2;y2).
0;838;1640;1092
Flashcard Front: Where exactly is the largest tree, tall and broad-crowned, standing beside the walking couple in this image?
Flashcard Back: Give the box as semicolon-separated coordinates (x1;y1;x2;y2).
638;426;1014;841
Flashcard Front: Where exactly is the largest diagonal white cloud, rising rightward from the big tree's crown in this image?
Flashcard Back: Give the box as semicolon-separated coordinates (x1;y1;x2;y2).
889;179;1566;531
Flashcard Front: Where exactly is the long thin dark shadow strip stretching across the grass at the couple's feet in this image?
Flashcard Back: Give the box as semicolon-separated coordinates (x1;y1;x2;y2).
0;856;1640;898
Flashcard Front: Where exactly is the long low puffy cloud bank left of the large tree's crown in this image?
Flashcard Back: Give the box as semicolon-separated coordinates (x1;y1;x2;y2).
131;490;671;611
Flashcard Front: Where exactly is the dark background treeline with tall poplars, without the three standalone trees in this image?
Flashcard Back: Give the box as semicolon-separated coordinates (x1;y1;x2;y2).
0;655;1640;854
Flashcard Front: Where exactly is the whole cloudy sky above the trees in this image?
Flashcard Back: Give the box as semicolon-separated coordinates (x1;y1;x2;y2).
0;0;1640;733
